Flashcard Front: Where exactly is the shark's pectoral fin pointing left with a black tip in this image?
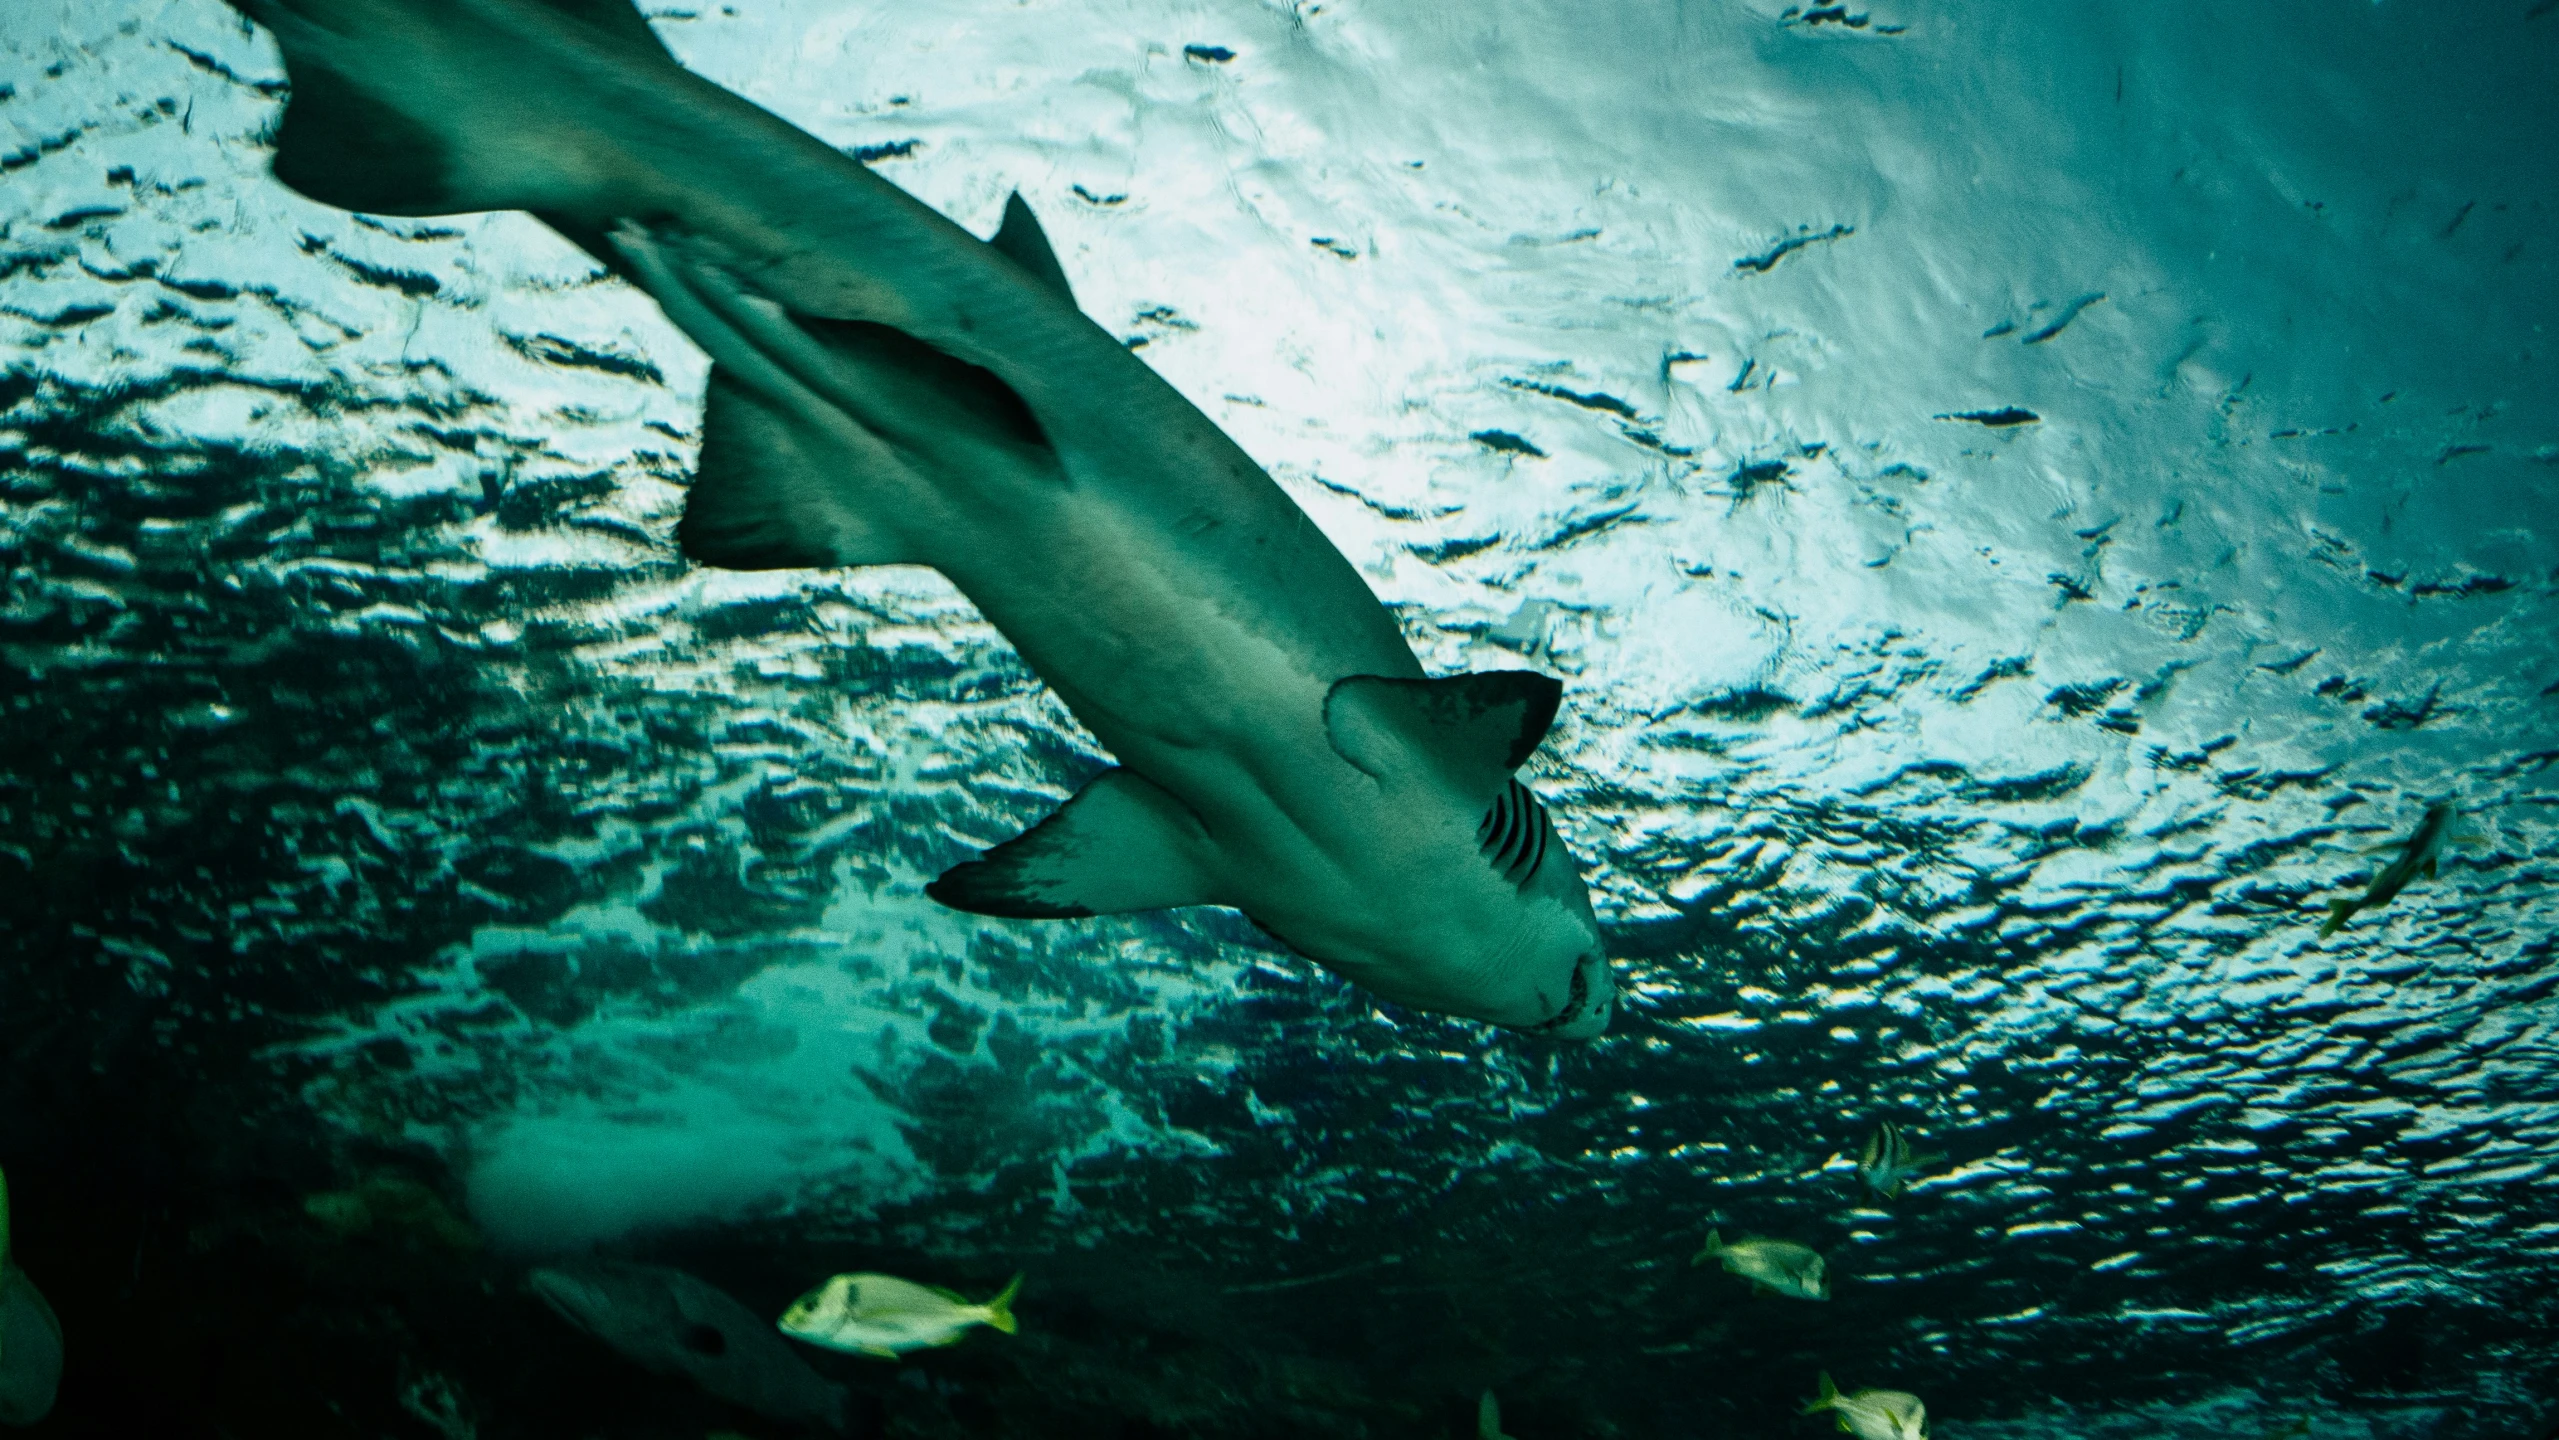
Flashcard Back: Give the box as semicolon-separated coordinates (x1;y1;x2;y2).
924;770;1223;921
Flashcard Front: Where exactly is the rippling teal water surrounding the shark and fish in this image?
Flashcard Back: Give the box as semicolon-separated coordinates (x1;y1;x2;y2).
0;0;2559;1440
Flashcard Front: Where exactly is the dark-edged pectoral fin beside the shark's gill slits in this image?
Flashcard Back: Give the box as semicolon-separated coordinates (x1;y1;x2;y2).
1323;670;1564;803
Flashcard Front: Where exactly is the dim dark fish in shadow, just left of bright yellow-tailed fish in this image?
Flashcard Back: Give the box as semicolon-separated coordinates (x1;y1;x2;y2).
527;1261;844;1435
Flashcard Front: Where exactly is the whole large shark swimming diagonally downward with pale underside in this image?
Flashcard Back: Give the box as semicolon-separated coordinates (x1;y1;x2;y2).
233;0;1615;1038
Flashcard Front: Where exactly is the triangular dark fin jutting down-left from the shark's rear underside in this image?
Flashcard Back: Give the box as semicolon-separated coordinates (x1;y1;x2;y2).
676;366;916;570
